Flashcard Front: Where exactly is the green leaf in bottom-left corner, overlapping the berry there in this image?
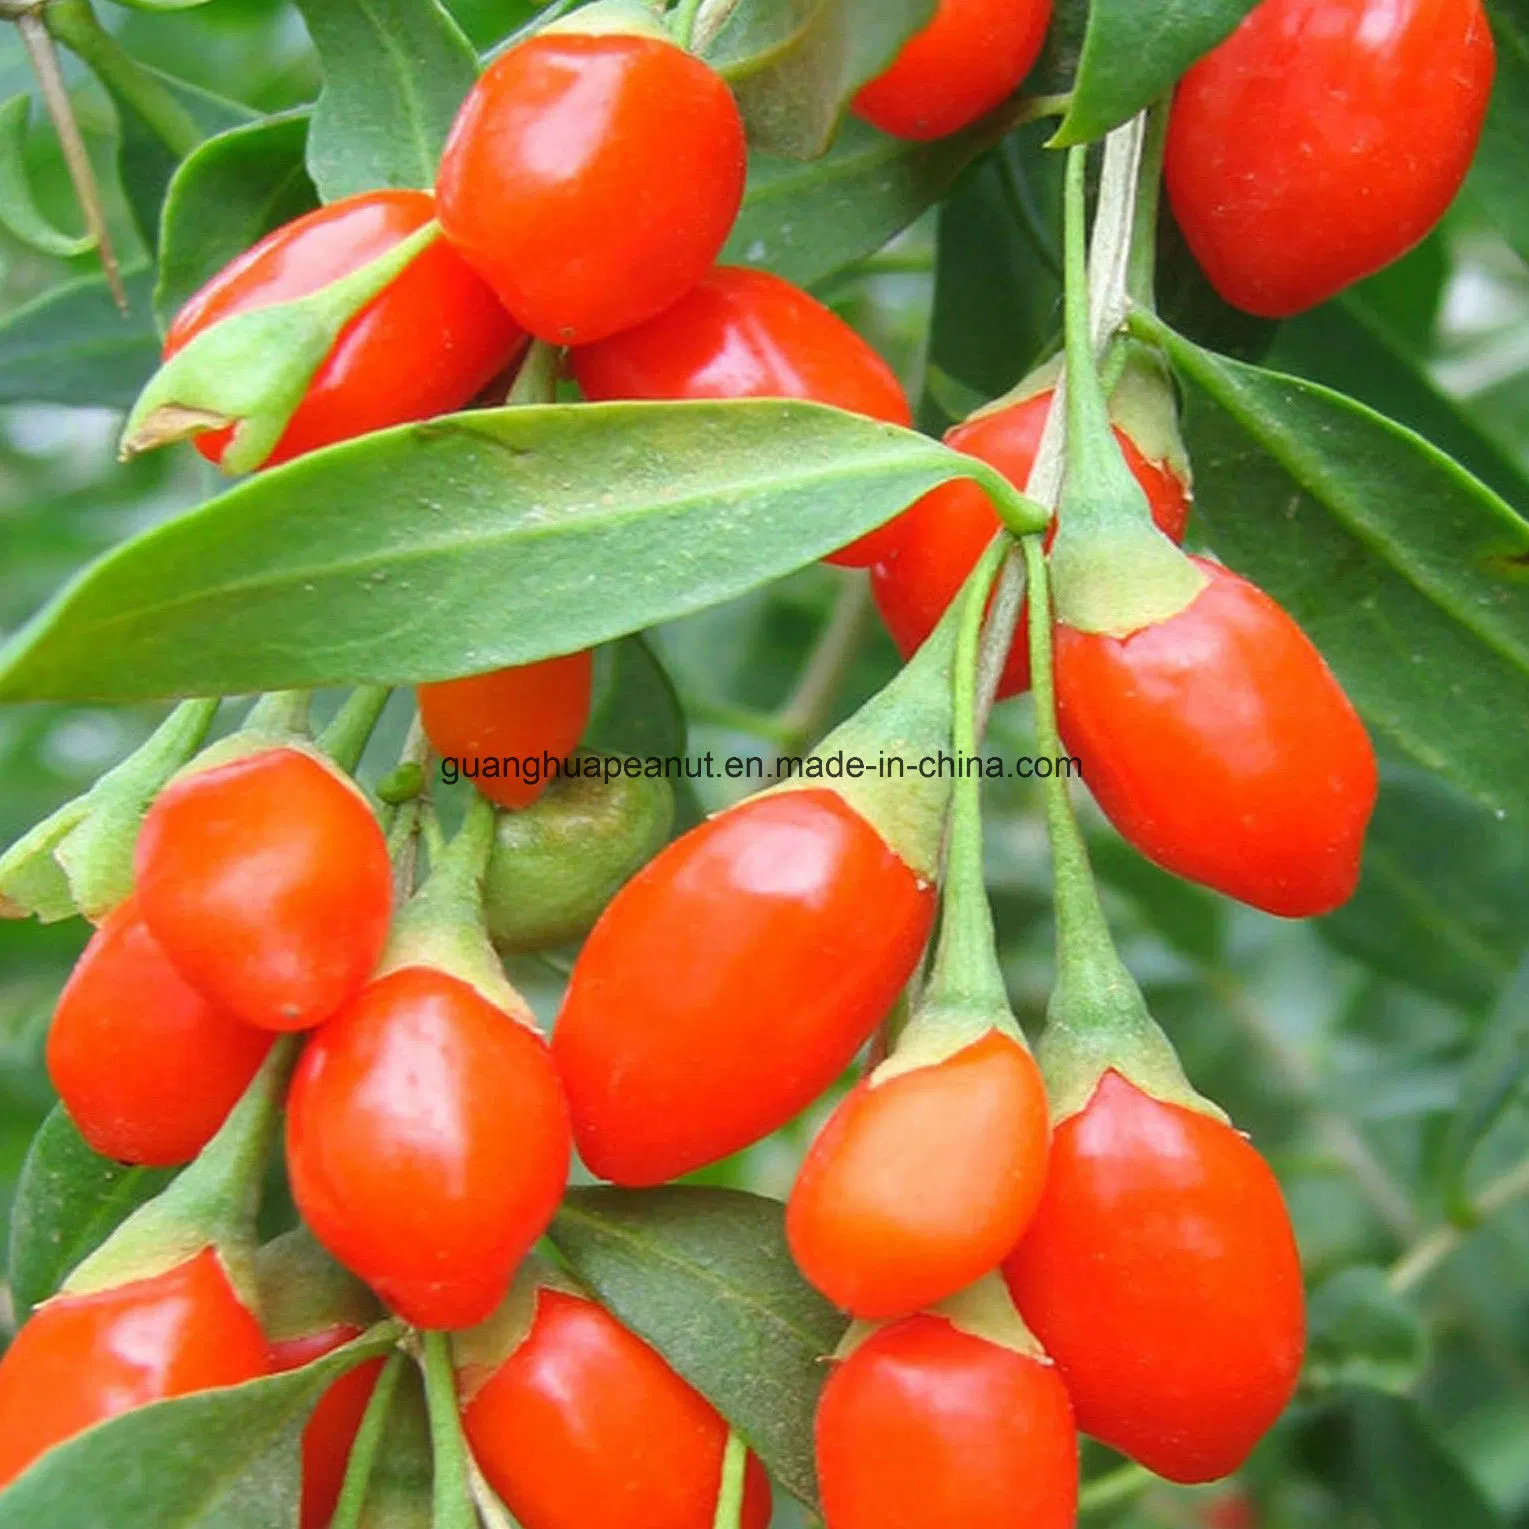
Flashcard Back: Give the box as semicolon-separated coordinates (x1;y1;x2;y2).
0;1323;398;1529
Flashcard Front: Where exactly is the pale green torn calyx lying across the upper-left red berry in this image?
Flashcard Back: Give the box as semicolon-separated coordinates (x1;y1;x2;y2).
119;223;440;472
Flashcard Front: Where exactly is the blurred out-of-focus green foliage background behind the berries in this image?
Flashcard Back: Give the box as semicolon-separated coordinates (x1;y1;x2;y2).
0;0;1529;1529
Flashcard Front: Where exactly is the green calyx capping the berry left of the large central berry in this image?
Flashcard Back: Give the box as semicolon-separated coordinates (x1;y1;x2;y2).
373;794;537;1031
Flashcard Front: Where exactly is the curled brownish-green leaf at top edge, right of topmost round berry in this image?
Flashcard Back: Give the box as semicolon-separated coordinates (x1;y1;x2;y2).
700;0;937;159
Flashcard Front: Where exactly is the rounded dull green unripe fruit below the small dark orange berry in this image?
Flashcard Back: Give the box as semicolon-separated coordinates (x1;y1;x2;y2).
483;775;674;951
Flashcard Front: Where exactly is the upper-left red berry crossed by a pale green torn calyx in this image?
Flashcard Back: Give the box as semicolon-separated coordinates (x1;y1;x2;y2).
165;191;526;466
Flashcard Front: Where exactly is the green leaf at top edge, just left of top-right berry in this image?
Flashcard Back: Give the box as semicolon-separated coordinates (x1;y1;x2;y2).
1055;0;1257;147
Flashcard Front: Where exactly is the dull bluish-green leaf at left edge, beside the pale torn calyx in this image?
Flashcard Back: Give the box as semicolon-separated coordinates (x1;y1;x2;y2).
0;269;159;408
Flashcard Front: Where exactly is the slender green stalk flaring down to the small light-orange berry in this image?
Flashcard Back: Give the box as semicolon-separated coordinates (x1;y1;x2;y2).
914;534;1009;1026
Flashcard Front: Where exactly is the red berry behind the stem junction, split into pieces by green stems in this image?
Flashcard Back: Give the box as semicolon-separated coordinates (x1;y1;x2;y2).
870;388;1190;697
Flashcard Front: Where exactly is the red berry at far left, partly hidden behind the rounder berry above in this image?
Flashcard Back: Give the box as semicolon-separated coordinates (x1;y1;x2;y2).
47;898;275;1168
